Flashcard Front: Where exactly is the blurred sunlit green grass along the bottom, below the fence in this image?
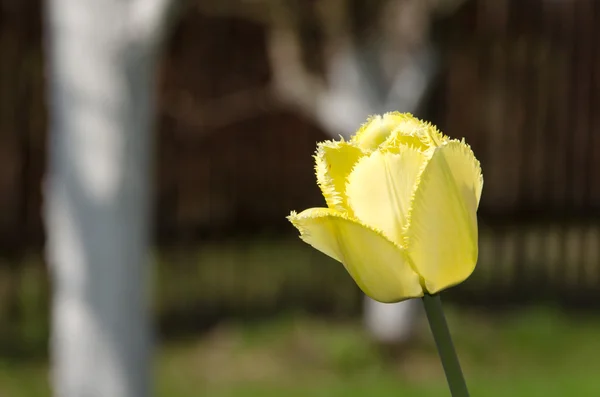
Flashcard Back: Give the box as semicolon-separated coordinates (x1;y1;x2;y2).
0;307;600;397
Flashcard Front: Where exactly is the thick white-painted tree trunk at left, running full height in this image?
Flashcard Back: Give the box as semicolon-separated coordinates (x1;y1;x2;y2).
45;0;167;397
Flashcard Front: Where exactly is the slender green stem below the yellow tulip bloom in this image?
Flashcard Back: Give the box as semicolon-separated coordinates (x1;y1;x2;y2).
423;294;469;397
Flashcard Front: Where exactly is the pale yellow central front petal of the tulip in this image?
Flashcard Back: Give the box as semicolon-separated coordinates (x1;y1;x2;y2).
346;145;428;244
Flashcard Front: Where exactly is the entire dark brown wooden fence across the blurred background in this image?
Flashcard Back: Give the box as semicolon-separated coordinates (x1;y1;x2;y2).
0;0;600;312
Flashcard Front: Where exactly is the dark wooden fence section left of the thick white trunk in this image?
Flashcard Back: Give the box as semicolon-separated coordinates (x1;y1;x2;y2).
0;0;46;256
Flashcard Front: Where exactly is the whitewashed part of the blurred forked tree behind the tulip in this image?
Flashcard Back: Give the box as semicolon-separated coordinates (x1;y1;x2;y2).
318;46;437;345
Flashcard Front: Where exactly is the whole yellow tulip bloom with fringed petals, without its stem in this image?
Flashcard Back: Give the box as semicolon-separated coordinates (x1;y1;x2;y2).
288;112;483;303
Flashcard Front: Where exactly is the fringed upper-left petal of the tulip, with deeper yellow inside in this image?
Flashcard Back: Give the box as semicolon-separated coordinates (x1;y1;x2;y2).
315;141;364;212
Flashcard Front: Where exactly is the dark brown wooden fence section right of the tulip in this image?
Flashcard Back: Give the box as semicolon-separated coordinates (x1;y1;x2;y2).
442;0;600;301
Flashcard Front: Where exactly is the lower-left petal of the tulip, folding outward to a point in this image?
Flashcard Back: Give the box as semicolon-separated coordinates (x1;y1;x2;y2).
288;208;423;303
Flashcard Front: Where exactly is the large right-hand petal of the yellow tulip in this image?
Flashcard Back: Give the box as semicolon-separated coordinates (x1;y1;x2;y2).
404;141;483;294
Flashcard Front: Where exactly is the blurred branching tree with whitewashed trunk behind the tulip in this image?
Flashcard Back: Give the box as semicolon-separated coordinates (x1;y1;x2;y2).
198;0;446;350
